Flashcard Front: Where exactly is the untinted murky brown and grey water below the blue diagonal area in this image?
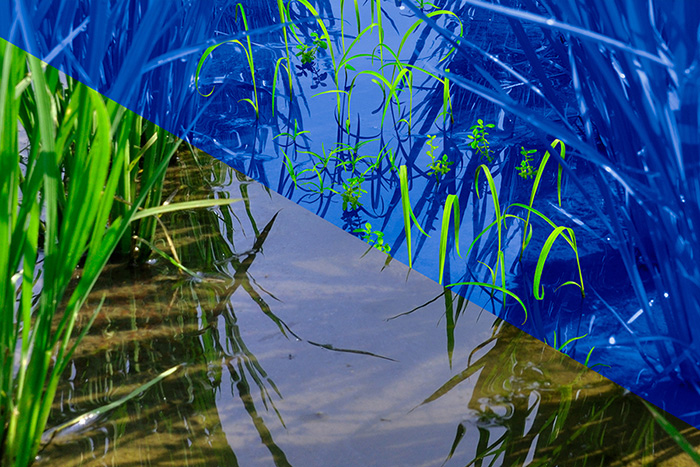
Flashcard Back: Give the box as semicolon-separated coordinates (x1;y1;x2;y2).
38;155;700;466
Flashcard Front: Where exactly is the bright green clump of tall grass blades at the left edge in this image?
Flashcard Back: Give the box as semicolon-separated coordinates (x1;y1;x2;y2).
0;41;235;466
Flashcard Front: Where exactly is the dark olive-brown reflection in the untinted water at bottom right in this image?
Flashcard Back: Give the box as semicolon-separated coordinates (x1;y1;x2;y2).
421;321;700;466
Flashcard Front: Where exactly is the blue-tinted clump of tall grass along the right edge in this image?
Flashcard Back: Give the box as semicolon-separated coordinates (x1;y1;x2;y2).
407;0;700;410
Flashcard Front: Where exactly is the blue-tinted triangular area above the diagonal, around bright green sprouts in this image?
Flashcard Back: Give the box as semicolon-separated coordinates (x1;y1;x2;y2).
0;0;700;432
